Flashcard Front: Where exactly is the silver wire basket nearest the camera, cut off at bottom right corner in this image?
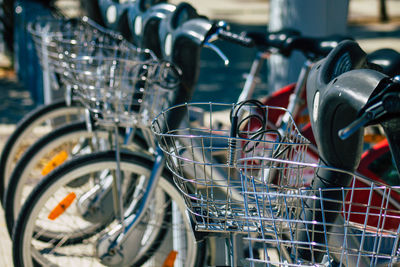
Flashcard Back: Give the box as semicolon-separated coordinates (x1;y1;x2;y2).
240;157;400;266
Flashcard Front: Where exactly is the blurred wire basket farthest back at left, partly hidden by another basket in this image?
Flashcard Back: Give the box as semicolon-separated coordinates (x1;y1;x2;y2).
27;17;133;90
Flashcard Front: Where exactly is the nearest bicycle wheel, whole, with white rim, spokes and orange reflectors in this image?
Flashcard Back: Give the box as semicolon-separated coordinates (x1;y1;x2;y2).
13;151;205;266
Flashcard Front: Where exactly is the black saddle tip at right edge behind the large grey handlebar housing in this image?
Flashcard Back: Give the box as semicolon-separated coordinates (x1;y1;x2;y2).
367;48;400;77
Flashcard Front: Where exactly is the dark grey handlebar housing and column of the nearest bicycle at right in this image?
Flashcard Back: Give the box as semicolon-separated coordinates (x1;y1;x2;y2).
296;41;400;262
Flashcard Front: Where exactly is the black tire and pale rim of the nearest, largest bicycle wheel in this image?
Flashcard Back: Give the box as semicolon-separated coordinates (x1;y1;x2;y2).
13;151;205;266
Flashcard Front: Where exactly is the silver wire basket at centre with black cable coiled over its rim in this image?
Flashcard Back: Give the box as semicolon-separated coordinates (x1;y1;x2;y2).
152;103;309;232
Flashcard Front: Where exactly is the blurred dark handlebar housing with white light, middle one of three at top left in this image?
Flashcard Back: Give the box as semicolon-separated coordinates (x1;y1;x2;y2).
128;0;176;57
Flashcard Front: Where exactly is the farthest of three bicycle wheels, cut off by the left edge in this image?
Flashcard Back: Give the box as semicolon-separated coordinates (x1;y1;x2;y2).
0;101;84;200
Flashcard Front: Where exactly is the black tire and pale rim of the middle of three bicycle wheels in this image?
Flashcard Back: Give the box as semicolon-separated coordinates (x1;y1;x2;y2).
3;122;115;235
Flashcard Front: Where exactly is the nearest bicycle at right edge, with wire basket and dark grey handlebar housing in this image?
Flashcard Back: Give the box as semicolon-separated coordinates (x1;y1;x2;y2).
238;42;398;266
